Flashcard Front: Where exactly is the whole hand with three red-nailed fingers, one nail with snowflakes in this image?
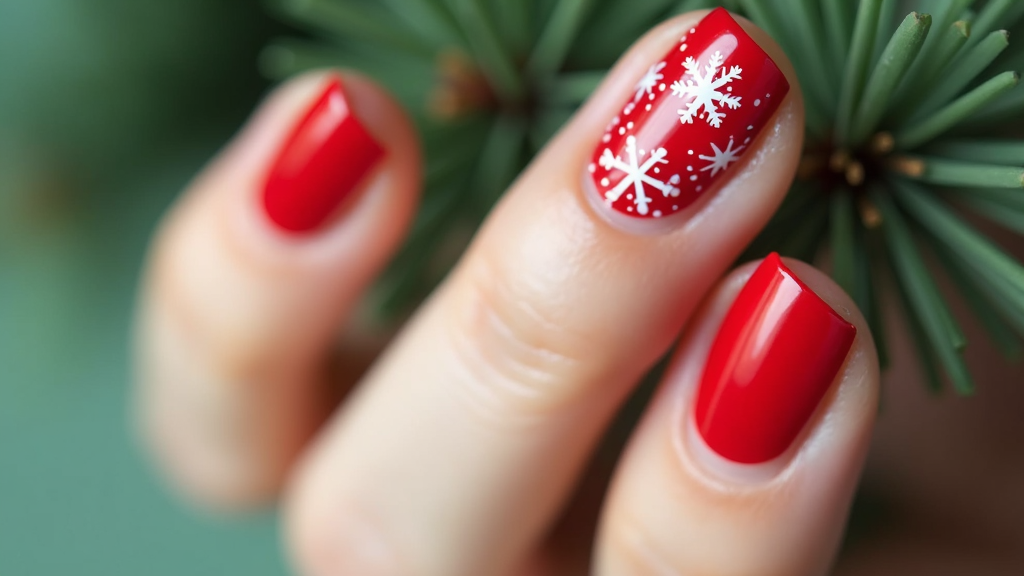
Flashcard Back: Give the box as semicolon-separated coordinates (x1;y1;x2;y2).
138;12;1024;576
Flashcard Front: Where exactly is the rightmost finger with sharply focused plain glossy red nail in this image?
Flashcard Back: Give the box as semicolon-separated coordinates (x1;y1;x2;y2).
596;254;879;576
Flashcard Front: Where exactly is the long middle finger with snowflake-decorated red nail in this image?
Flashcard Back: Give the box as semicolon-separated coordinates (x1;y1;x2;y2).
288;10;803;576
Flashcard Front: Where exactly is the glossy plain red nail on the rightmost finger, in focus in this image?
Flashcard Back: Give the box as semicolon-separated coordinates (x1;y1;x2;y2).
695;253;857;464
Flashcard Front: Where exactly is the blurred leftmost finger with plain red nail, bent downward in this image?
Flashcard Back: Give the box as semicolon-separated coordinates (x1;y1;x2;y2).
137;73;420;506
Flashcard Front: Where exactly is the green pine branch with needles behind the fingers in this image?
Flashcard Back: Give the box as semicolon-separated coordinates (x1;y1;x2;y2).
268;0;1024;394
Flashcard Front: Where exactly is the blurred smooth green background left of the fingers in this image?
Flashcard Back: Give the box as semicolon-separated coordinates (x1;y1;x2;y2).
0;0;286;576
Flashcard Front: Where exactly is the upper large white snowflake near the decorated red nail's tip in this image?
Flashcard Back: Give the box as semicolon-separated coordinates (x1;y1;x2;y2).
672;51;743;128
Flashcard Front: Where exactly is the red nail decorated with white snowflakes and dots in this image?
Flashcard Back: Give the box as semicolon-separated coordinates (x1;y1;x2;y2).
587;8;790;218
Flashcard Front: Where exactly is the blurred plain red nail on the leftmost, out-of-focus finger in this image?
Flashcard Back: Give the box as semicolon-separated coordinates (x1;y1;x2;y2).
263;79;384;233
